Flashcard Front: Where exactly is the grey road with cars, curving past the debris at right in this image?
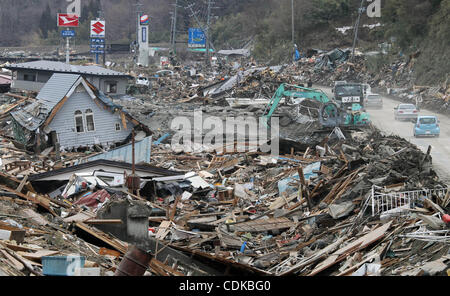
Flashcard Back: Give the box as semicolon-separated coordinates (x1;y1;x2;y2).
321;87;450;185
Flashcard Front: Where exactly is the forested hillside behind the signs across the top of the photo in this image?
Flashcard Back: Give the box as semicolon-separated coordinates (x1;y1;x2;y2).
0;0;450;81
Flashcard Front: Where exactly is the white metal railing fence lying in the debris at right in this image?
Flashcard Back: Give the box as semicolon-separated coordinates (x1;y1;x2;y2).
371;186;449;216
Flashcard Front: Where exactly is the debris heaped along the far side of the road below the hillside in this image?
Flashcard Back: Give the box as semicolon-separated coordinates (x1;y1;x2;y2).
287;49;450;115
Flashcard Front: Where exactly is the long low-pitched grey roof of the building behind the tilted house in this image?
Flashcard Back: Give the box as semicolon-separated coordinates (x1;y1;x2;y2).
5;60;131;77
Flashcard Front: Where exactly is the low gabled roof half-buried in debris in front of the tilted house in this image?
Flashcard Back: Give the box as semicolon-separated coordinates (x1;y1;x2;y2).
28;159;184;181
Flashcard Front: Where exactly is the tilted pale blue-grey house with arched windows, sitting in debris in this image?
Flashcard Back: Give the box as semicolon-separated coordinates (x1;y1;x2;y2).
11;73;151;150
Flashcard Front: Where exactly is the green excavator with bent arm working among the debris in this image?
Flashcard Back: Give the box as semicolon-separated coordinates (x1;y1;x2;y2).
262;83;370;129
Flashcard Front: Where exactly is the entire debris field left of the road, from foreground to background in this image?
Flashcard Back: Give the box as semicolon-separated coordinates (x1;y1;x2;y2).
0;51;450;276
